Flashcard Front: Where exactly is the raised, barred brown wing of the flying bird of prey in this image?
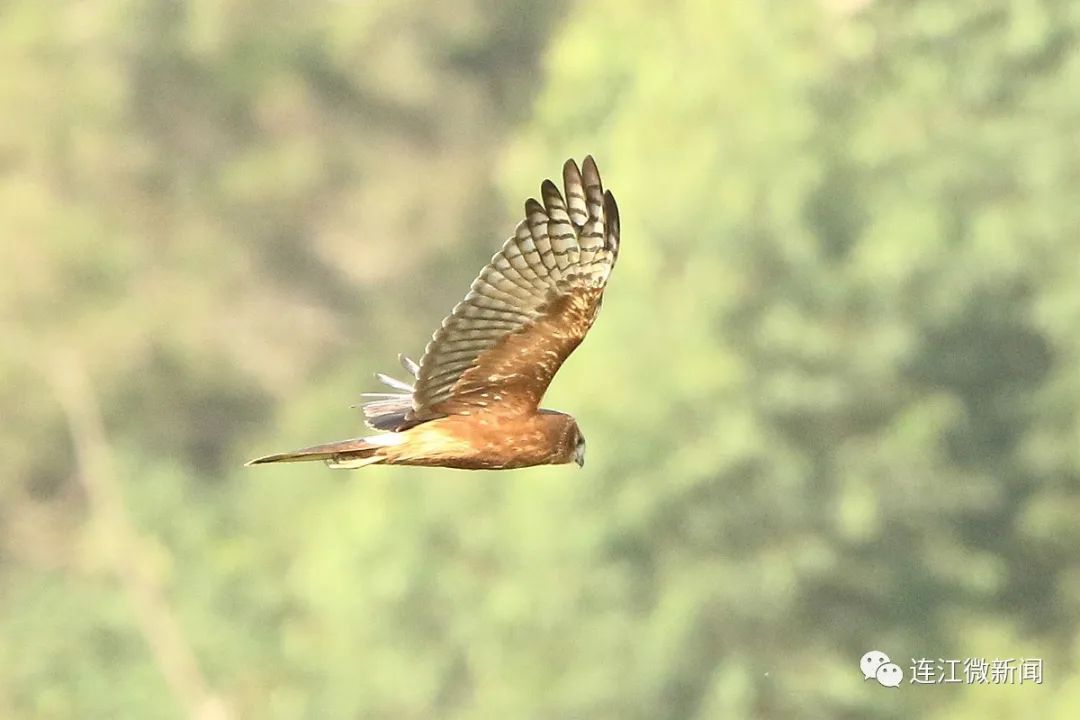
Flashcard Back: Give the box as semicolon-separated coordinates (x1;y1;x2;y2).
404;157;619;424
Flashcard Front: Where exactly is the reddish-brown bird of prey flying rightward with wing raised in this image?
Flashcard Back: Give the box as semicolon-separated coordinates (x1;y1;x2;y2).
248;157;619;470
